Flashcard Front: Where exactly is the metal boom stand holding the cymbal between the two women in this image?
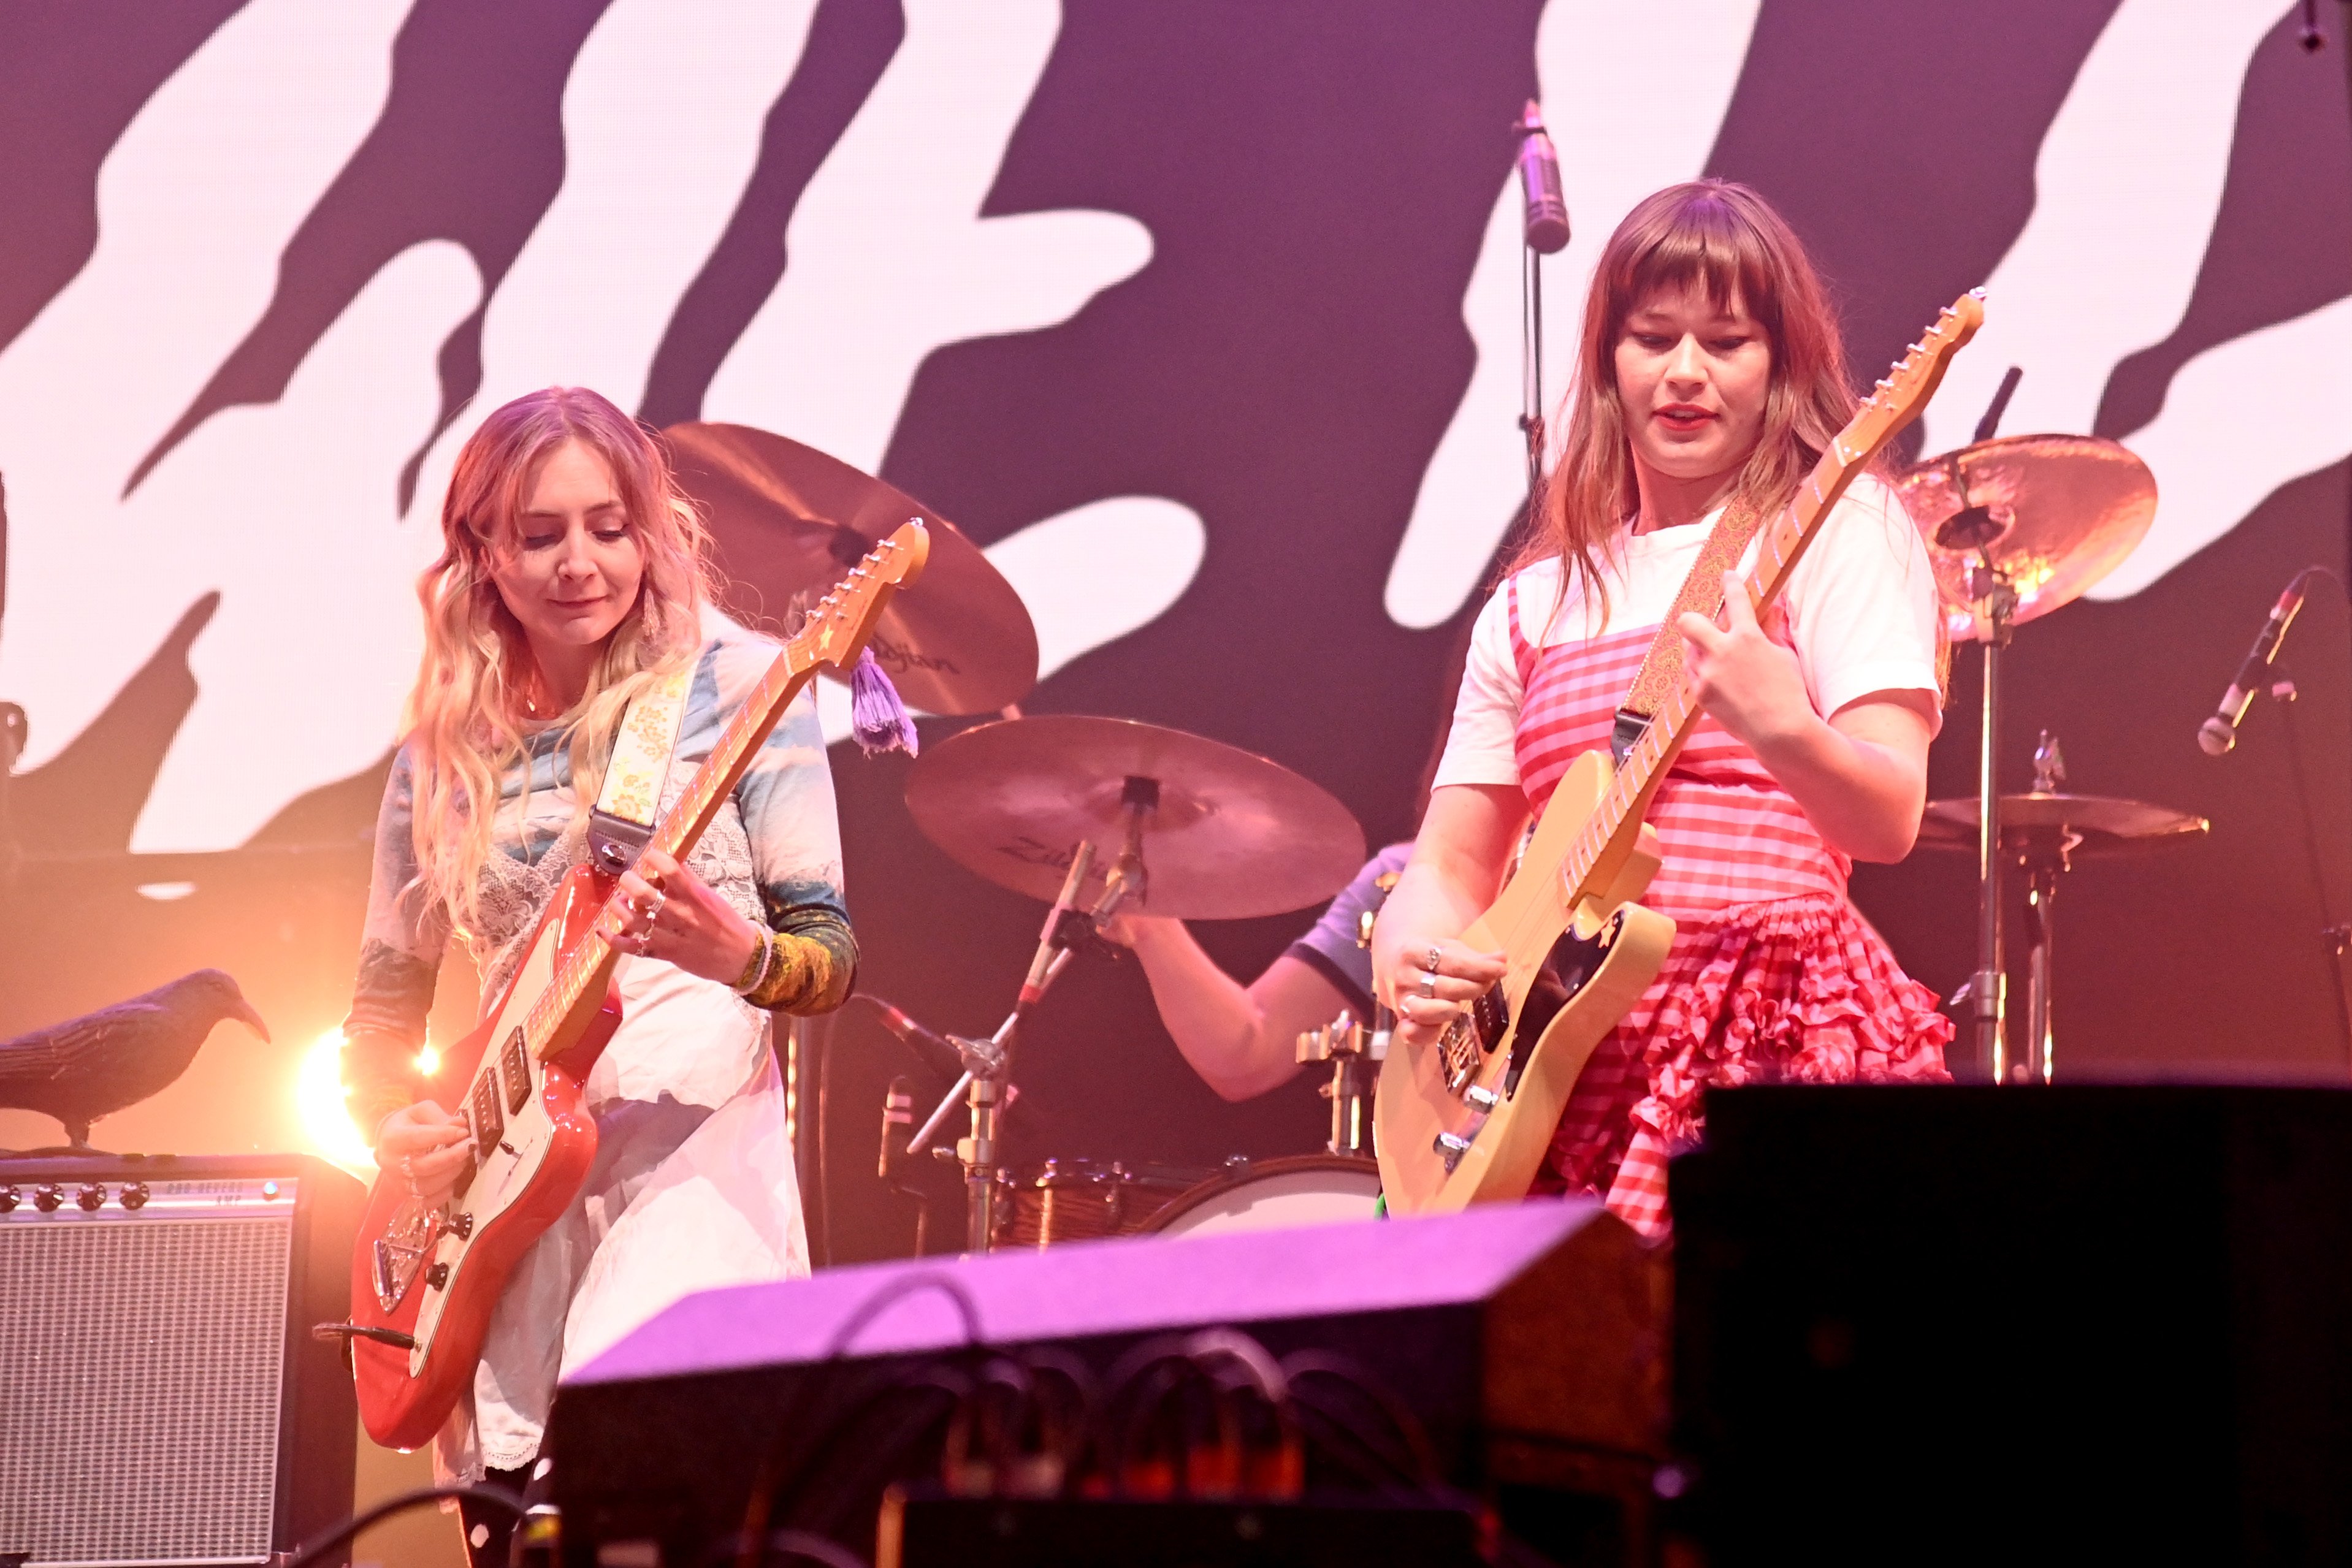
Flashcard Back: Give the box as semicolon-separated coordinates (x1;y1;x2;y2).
906;778;1159;1253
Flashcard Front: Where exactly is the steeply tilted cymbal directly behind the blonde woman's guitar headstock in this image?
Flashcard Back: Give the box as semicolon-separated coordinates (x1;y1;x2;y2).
663;421;1037;712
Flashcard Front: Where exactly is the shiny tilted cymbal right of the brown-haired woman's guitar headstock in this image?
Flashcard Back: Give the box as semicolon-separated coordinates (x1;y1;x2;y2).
1896;435;2157;642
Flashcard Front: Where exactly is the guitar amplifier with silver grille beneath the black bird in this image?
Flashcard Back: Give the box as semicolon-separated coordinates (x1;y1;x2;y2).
0;1154;365;1568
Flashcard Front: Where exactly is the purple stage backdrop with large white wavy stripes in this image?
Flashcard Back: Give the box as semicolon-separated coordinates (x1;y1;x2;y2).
0;0;2352;1258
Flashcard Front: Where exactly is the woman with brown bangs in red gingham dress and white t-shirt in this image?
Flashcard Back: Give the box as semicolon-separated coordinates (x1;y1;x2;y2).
1373;181;1952;1234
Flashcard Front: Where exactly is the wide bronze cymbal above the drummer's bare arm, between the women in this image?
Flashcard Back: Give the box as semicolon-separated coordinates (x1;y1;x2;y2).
906;712;1364;919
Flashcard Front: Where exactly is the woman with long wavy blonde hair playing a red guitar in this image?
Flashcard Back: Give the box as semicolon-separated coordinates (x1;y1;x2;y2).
343;388;856;1561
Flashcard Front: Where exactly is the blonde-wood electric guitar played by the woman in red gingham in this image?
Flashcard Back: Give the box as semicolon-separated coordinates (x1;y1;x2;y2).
1373;292;1985;1213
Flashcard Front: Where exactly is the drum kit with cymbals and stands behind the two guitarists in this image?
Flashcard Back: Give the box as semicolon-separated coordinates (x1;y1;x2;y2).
668;381;2206;1250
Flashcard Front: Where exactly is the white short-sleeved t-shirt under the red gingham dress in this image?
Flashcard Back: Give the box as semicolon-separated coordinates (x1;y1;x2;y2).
1432;475;1943;788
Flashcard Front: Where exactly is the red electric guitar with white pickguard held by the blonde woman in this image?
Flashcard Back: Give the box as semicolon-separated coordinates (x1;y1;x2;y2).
351;522;931;1448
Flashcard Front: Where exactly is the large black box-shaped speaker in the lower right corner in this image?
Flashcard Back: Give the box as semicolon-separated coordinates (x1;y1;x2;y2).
1670;1084;2352;1568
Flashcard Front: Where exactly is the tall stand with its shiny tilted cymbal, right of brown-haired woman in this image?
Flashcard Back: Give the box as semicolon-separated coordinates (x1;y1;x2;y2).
1896;392;2157;1084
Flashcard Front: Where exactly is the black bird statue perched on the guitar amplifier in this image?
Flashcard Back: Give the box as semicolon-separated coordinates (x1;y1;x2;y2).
0;969;270;1147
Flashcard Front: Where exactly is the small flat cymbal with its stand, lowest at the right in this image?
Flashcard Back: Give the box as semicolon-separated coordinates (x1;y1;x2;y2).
1919;731;2209;1084
